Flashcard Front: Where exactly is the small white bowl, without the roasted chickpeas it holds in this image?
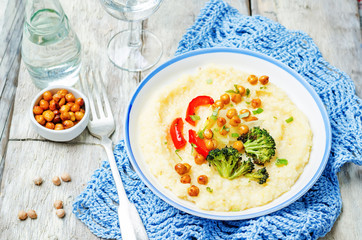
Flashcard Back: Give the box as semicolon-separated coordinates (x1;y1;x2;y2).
29;85;89;142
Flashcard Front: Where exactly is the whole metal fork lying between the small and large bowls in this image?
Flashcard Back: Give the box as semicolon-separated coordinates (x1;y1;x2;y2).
80;69;148;240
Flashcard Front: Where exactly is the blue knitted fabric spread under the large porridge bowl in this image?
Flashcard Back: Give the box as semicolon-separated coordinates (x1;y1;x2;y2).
73;0;362;240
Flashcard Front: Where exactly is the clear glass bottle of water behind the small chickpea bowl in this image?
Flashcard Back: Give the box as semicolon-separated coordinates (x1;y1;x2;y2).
21;0;81;89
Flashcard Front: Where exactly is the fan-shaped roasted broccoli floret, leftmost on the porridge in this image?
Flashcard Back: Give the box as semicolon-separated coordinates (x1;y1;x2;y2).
206;147;254;180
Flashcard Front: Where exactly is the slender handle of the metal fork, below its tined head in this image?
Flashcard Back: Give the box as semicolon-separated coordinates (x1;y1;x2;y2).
101;137;148;240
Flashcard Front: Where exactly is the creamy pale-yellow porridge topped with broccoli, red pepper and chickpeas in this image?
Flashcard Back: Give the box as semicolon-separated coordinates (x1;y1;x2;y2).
138;66;312;211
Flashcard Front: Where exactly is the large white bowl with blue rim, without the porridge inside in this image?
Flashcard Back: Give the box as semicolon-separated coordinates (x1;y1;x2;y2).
124;48;331;220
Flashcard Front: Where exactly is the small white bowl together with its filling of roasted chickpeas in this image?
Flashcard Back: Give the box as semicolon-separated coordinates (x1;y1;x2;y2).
29;86;89;142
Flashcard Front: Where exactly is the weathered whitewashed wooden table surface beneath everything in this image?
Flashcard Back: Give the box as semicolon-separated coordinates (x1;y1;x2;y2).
0;0;362;240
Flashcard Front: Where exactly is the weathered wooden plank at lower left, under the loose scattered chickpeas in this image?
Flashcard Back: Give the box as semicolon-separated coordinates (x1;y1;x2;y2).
0;141;100;240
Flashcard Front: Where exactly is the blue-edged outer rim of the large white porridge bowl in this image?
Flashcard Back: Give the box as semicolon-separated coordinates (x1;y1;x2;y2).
124;48;332;220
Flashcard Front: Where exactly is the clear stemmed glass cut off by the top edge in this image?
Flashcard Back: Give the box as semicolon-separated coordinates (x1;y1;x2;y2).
100;0;163;72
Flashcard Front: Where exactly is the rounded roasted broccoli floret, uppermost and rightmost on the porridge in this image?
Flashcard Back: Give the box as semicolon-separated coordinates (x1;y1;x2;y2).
238;127;275;165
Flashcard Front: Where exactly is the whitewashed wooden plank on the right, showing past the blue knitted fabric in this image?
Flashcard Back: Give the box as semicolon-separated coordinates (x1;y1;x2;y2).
251;0;362;240
